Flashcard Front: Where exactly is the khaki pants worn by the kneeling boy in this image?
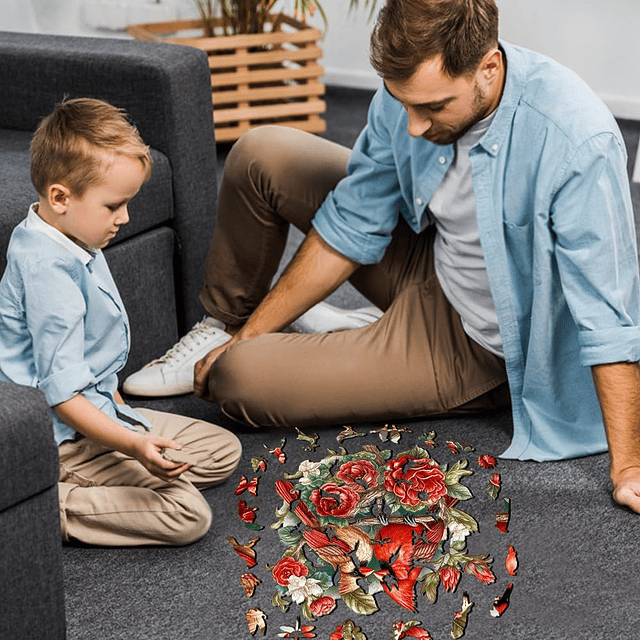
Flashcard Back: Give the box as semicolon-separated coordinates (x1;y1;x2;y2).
58;409;241;546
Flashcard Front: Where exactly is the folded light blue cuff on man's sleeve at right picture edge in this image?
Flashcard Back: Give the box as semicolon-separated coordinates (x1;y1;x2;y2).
579;327;640;367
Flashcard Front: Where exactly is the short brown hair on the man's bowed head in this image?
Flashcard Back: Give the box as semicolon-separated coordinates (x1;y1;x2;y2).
371;0;498;81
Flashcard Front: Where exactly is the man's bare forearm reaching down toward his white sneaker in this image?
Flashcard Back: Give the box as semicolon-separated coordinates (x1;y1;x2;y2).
236;229;360;341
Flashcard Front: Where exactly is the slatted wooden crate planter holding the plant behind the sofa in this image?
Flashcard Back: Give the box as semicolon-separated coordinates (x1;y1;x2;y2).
127;15;326;142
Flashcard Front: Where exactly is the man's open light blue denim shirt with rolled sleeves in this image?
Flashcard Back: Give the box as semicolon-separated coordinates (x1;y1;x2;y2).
313;42;640;460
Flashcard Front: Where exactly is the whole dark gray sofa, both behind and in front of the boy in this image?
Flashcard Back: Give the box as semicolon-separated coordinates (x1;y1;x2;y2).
0;28;217;640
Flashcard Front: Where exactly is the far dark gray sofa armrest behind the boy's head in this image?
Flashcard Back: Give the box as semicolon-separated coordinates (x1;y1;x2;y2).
0;32;217;332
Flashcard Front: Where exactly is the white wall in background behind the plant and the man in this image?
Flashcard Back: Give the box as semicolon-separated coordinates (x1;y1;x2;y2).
0;0;640;120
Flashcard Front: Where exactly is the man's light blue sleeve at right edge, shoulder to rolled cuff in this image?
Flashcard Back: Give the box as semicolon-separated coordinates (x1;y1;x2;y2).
552;134;640;366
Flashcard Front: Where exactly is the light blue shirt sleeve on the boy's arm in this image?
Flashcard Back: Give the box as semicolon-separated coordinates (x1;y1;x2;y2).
23;259;96;406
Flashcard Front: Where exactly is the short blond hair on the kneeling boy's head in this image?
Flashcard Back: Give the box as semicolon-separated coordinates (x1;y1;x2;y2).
31;98;153;198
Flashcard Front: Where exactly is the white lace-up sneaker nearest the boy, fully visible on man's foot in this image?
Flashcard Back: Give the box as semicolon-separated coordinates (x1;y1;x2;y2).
122;316;231;397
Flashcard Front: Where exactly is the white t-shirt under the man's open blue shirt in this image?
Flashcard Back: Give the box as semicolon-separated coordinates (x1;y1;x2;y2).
428;111;503;357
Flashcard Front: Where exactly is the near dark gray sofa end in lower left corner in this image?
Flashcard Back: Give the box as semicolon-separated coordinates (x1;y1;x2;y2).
0;383;65;640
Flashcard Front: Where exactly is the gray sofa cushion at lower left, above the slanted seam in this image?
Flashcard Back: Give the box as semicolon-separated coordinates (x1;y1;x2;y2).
0;382;59;512
